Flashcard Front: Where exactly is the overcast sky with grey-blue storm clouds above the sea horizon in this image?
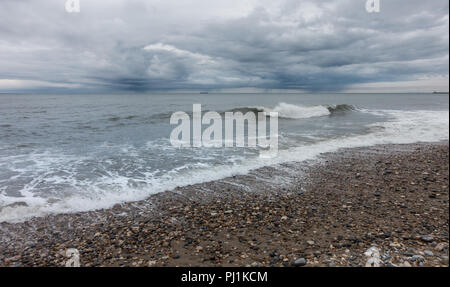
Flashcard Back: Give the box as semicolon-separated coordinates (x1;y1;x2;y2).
0;0;449;93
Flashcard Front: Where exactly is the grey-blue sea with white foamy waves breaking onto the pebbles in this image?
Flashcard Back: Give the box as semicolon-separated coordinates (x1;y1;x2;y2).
0;94;449;222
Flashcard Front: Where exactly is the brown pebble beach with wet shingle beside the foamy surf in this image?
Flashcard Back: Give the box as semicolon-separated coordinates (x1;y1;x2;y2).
0;141;449;266
